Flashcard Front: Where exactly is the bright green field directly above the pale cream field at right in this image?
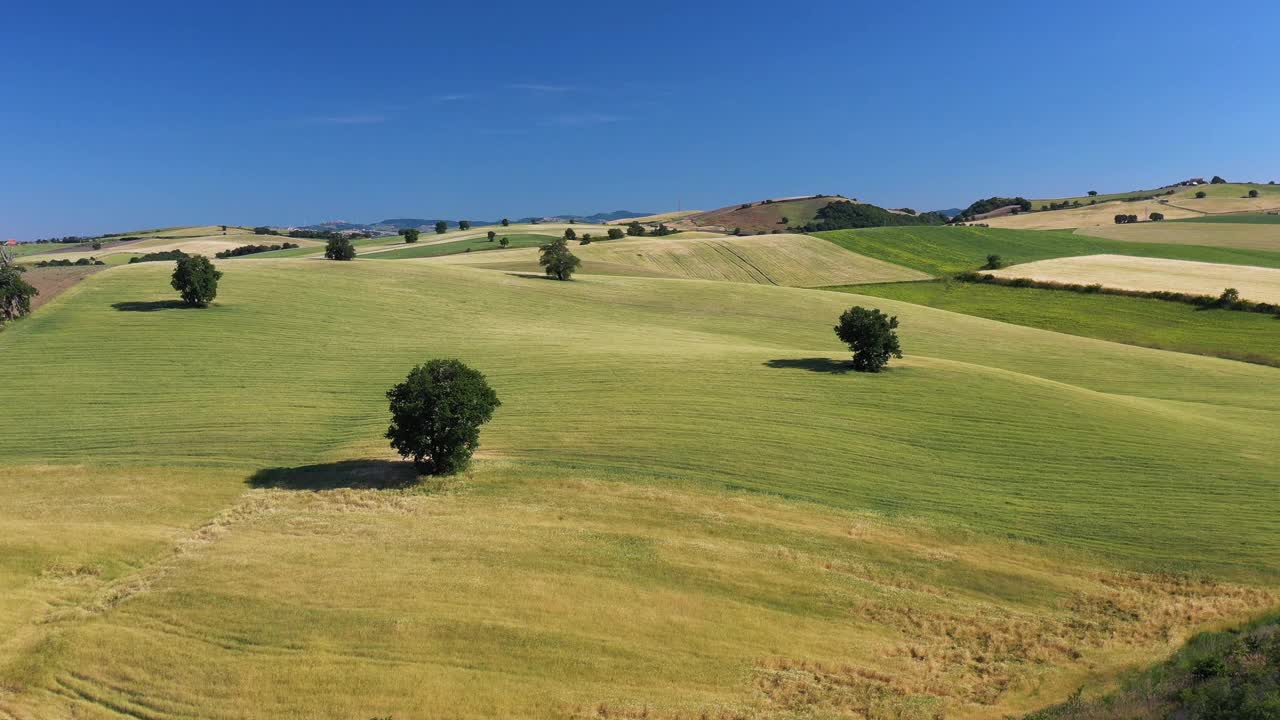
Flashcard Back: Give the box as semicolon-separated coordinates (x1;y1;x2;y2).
817;227;1280;275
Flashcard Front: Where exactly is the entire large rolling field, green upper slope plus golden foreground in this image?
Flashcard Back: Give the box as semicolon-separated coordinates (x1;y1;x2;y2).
0;260;1280;720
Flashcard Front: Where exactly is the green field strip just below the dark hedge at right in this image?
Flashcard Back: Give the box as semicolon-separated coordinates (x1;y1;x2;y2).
838;281;1280;366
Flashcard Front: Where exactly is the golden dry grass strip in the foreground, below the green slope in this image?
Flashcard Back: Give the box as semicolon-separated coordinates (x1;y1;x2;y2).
0;462;1277;720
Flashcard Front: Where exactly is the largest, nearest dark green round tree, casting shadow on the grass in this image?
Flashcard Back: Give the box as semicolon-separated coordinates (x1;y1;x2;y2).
387;360;502;475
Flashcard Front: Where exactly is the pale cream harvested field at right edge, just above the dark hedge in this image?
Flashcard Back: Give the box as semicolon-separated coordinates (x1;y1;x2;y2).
991;255;1280;302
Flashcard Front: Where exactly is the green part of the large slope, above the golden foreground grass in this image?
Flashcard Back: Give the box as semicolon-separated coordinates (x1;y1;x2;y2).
0;261;1280;566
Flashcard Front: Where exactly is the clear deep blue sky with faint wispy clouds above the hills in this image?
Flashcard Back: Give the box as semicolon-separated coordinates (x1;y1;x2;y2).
0;0;1280;240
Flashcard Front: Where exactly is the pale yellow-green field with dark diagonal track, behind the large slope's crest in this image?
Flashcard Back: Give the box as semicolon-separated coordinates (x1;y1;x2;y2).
430;234;929;287
